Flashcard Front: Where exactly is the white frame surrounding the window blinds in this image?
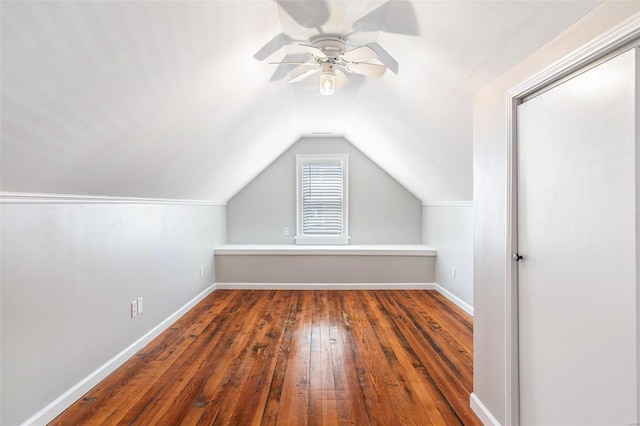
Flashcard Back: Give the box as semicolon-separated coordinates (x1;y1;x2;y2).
295;154;351;245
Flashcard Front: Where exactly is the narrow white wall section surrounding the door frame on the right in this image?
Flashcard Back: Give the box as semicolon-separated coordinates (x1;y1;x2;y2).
473;1;640;424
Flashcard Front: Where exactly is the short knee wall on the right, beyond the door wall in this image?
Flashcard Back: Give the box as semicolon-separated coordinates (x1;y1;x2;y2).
422;203;473;313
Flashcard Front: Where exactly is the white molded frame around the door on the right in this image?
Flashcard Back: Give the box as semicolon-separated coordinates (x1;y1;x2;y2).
505;13;640;426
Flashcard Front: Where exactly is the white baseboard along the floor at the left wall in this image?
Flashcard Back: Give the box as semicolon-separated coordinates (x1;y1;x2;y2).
23;284;216;425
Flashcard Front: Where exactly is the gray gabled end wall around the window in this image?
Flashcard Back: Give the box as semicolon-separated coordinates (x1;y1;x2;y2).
227;138;422;244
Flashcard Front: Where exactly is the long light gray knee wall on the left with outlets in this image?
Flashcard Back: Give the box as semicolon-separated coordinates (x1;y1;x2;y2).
0;203;225;425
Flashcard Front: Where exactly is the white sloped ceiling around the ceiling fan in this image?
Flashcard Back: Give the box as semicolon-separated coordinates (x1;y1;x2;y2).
0;0;599;202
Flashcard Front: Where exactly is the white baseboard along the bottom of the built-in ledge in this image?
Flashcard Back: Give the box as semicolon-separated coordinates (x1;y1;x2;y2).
216;283;437;290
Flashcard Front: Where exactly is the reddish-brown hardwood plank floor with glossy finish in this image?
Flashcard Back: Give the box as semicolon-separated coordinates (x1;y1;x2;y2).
52;290;481;425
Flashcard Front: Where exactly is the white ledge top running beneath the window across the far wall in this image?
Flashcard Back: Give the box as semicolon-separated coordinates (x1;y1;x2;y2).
214;244;437;257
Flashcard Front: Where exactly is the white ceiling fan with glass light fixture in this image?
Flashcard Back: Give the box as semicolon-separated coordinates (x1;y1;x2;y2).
270;34;387;95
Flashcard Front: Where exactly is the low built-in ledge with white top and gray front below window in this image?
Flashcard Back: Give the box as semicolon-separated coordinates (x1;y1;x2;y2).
214;244;436;288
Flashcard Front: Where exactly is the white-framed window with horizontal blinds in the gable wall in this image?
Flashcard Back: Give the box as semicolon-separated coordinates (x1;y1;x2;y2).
296;154;349;244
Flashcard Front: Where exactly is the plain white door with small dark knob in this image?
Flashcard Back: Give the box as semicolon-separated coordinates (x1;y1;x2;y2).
517;49;638;425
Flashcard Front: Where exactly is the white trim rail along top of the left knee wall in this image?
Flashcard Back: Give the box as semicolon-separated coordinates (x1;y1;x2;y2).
0;192;226;206
